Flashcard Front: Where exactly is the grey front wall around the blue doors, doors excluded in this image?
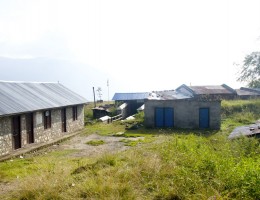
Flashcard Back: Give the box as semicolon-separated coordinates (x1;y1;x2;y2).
144;99;221;129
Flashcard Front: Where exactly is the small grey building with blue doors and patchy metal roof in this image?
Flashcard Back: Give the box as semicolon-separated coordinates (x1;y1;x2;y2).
144;91;221;129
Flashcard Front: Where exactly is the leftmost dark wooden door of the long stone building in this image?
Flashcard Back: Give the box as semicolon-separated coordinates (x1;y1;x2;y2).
12;116;21;149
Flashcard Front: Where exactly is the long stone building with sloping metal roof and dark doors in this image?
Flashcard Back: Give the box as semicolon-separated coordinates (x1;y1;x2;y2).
0;81;86;156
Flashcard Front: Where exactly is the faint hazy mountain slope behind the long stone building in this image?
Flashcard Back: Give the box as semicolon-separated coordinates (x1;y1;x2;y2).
0;57;110;100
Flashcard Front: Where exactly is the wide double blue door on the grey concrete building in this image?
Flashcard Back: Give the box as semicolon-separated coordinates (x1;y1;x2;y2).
155;108;174;128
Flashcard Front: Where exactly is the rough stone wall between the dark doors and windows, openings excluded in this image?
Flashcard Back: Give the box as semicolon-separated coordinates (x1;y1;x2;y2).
0;105;84;156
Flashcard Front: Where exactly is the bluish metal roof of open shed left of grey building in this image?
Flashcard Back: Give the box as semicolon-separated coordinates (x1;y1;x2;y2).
112;92;149;101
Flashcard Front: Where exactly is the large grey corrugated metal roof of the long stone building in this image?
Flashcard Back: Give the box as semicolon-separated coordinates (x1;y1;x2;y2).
0;81;87;116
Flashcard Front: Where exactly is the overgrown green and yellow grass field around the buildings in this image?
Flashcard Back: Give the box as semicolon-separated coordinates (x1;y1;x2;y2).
0;100;260;200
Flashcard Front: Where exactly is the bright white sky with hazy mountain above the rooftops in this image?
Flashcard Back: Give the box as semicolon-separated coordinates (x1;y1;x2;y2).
0;0;260;101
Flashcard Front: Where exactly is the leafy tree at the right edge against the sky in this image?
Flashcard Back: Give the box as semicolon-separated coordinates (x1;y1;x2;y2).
237;52;260;88
